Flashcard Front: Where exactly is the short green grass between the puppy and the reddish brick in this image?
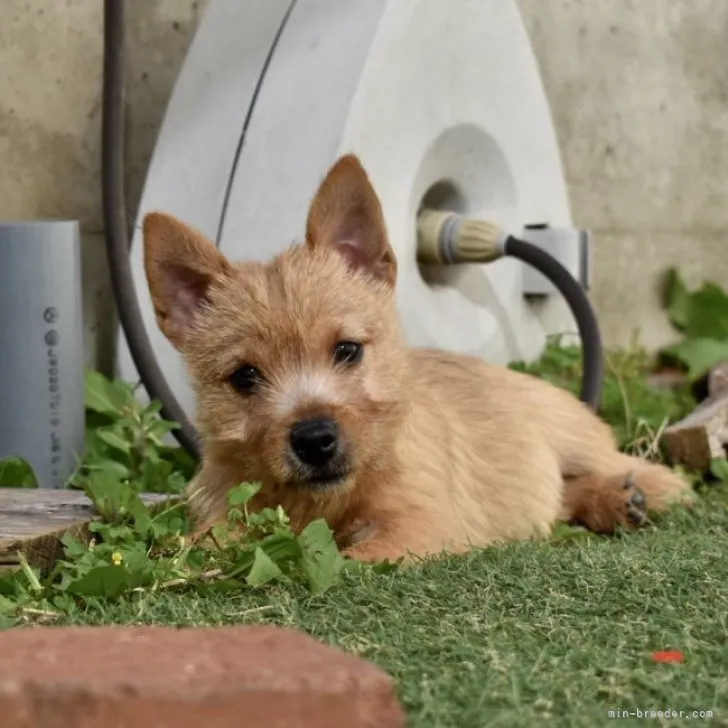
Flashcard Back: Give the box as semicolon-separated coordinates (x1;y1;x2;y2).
52;487;728;728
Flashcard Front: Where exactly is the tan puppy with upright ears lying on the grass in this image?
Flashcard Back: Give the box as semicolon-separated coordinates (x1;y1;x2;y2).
144;155;690;561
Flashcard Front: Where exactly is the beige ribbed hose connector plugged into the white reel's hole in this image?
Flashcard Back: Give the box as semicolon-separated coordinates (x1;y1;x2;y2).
417;209;508;265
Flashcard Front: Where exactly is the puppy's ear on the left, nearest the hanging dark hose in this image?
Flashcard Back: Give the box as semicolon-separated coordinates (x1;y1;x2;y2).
143;212;230;349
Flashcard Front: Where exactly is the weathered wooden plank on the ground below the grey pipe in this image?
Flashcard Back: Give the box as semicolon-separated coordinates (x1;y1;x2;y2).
0;488;176;572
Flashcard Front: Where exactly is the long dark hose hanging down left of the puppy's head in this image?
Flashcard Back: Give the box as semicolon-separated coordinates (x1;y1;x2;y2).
101;0;199;459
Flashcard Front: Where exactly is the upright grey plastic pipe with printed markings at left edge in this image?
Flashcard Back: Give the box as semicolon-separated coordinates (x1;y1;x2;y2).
0;221;85;488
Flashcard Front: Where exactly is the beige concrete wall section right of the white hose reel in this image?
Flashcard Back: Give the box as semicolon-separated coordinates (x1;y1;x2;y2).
520;0;728;347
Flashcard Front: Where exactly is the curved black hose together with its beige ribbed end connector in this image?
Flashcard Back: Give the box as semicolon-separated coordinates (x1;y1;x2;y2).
417;209;604;410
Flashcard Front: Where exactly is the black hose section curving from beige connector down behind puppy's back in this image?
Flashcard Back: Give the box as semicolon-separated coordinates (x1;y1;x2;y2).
504;236;604;410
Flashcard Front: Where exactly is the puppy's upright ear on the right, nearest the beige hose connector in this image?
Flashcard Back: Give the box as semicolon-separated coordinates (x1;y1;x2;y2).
306;154;397;285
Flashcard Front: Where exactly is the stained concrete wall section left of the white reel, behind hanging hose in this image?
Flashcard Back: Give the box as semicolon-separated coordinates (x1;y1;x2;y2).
0;0;204;371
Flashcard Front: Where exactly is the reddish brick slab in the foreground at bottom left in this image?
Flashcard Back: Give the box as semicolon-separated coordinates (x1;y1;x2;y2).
0;625;407;728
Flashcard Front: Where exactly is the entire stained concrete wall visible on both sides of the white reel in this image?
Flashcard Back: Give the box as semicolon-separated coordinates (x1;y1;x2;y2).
0;0;728;369
